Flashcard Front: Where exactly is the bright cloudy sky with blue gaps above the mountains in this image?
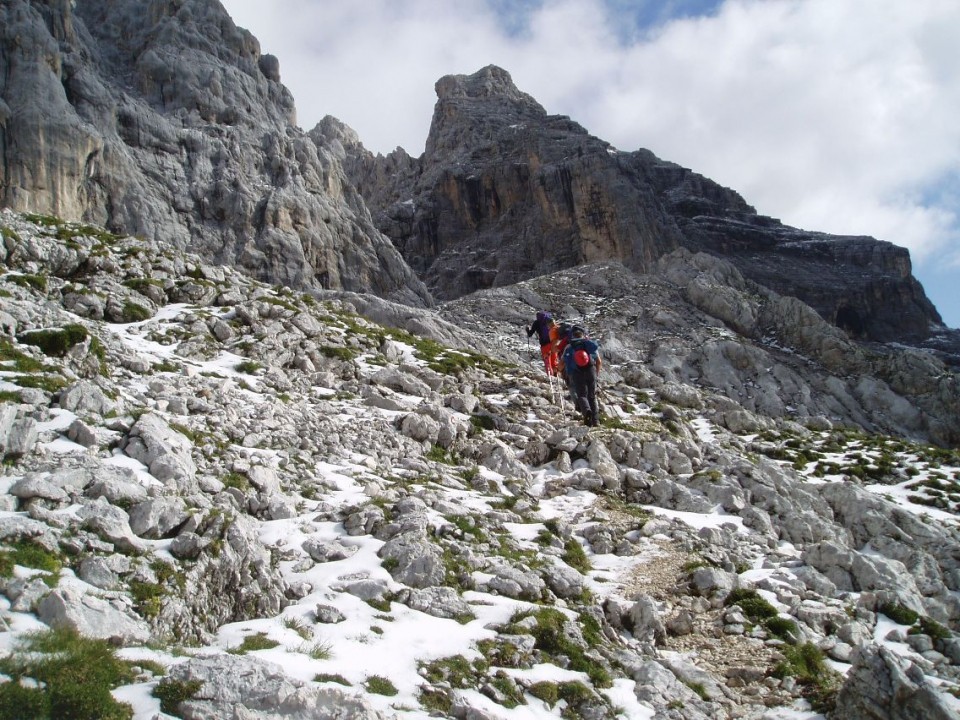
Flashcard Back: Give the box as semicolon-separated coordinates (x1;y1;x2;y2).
222;0;960;327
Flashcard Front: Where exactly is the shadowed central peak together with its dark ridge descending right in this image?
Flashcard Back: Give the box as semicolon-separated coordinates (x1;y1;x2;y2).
330;66;958;344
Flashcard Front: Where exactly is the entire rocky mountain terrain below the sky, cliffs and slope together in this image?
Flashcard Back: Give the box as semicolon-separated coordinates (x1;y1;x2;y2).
0;0;960;720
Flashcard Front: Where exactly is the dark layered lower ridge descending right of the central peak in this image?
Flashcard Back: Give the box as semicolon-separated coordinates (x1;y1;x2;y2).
633;164;940;352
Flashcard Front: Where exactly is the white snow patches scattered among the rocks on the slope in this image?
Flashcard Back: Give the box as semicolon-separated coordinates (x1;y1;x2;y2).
0;305;960;720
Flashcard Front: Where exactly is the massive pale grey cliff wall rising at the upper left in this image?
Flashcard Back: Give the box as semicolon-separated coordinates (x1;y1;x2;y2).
0;0;432;305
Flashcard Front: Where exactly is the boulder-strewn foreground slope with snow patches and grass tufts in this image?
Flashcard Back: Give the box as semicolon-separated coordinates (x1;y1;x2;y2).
0;212;960;720
